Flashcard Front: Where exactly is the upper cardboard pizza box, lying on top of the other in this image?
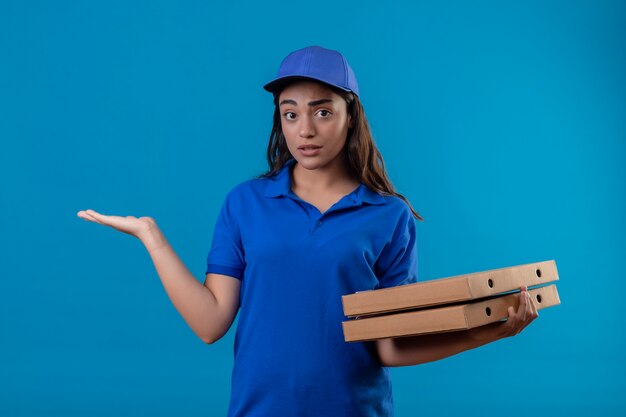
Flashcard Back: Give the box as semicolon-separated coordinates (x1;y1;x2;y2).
342;260;559;317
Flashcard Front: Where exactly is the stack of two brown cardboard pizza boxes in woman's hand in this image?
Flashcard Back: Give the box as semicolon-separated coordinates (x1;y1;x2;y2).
342;261;560;342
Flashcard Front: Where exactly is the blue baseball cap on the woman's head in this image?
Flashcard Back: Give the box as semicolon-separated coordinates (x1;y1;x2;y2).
263;46;359;96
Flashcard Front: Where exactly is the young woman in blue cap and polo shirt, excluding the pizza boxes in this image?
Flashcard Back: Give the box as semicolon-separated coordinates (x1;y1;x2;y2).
78;47;537;417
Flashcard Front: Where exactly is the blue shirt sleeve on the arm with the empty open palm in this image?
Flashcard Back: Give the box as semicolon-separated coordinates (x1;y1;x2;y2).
206;193;245;279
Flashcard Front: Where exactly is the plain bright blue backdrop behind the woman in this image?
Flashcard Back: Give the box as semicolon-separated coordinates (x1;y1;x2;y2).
0;0;626;417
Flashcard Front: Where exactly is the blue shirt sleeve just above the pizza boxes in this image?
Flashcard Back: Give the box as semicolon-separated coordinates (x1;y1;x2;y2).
375;206;417;288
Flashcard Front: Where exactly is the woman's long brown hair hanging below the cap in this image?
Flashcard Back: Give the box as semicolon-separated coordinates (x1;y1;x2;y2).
261;79;424;220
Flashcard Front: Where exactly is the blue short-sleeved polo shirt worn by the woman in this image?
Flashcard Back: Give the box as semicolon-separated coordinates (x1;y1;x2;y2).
206;159;417;417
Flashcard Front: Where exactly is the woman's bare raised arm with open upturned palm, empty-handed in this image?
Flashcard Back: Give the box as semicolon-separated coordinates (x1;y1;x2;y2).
77;210;240;343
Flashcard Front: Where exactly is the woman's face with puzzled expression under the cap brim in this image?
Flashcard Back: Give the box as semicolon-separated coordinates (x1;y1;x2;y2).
278;81;350;171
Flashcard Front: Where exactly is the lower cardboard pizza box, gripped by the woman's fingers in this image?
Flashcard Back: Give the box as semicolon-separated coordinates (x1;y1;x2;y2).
342;285;560;342
